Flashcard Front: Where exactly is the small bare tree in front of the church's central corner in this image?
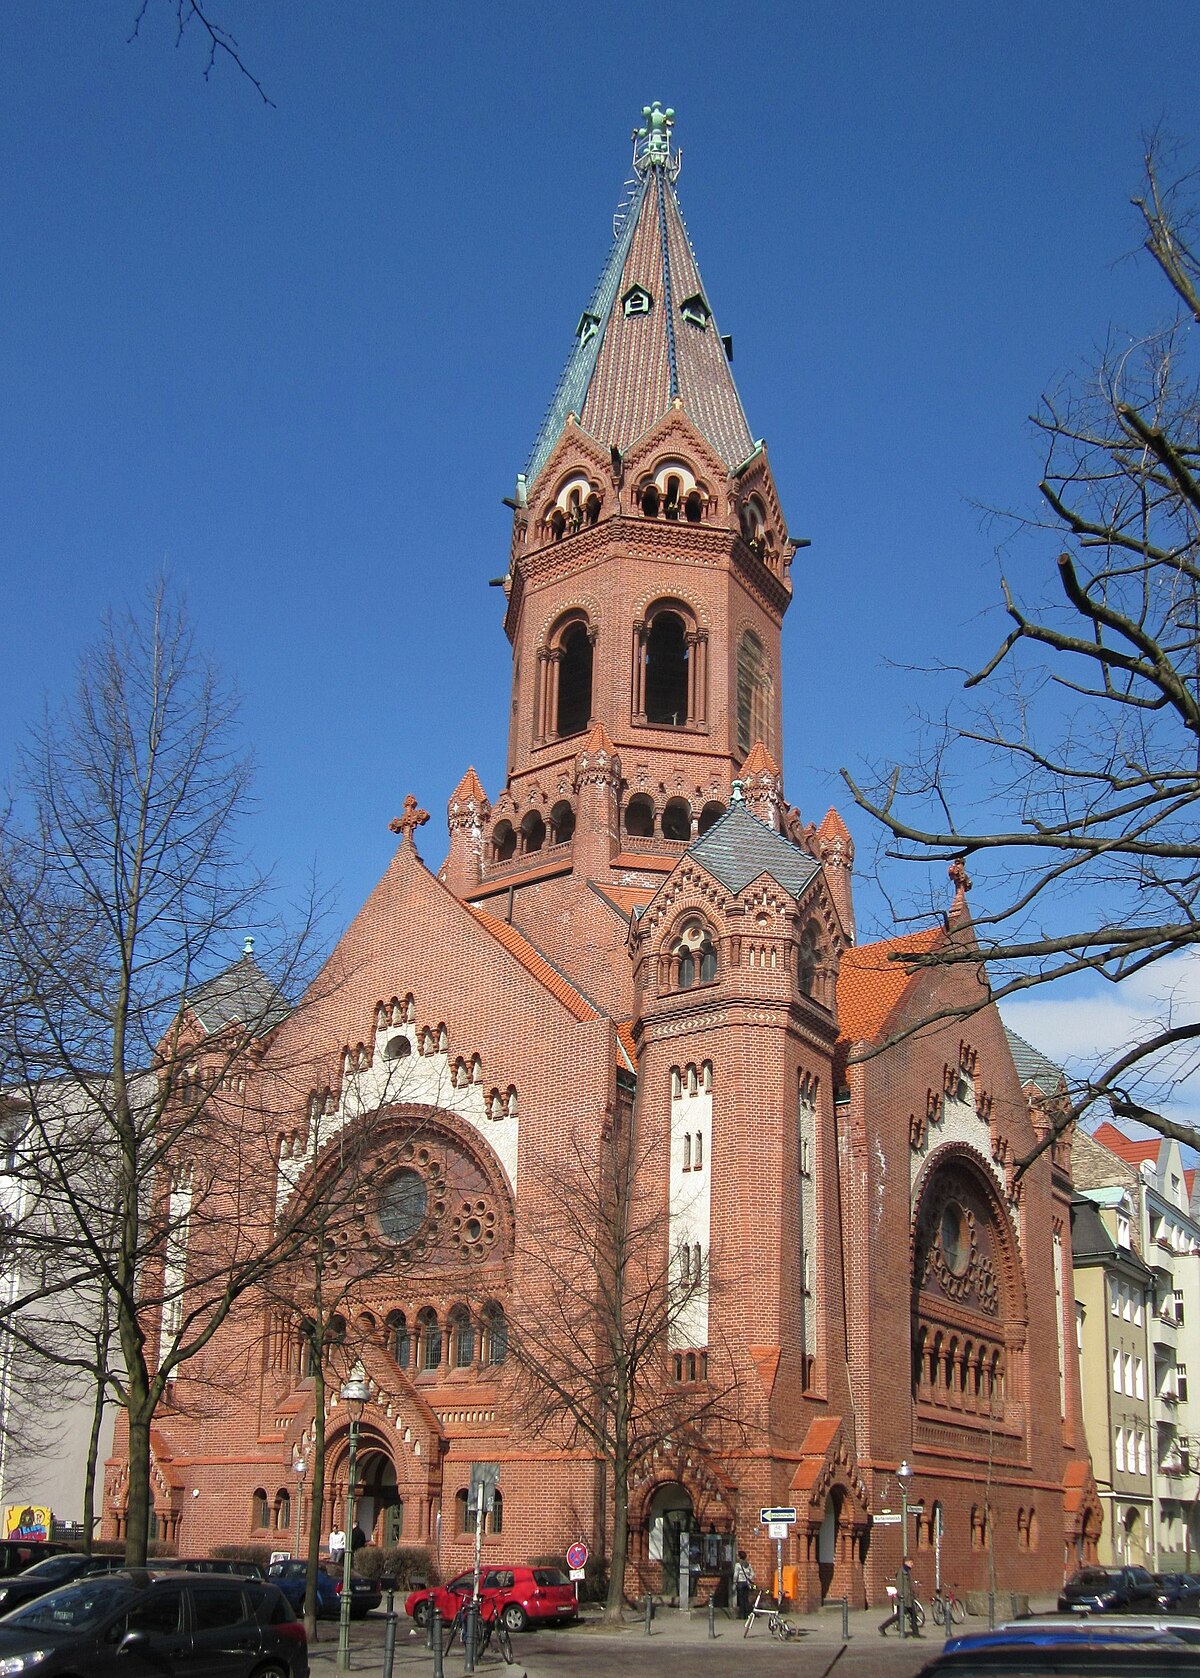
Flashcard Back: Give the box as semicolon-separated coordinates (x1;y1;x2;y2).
510;1109;745;1619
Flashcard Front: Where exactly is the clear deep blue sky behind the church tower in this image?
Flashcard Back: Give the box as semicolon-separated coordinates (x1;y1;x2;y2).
0;0;1200;1107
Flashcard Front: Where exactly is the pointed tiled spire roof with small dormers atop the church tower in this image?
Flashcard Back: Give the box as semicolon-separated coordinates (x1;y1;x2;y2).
525;106;754;483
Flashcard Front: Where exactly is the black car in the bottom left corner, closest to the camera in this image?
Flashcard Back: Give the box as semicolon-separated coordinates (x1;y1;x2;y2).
0;1567;309;1678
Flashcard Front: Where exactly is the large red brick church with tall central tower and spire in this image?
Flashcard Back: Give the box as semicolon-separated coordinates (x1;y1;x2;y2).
104;107;1099;1606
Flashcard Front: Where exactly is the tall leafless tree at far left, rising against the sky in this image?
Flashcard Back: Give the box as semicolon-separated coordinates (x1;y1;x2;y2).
0;589;328;1562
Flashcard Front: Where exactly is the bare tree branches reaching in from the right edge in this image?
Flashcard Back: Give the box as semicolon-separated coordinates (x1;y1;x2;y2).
843;144;1200;1146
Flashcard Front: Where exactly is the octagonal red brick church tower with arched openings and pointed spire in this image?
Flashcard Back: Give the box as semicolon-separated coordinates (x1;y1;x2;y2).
443;104;815;1012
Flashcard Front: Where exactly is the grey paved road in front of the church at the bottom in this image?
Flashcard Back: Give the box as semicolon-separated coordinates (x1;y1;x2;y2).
300;1609;983;1678
